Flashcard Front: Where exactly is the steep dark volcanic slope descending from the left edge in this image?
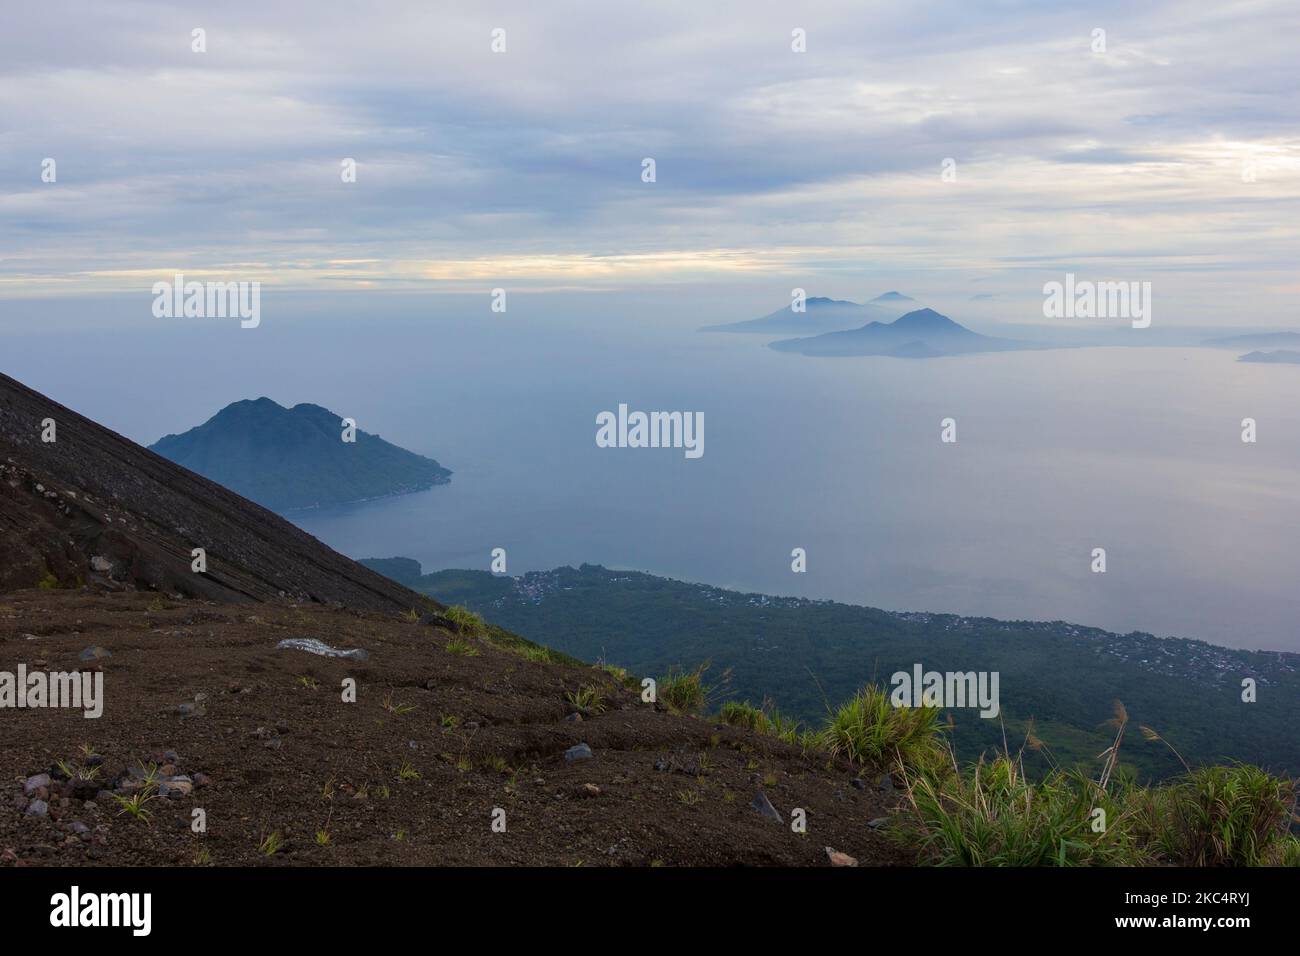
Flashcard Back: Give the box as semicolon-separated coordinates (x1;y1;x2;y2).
0;375;429;610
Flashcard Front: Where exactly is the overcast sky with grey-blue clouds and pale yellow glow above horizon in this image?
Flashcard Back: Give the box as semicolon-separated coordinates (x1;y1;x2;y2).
0;0;1300;325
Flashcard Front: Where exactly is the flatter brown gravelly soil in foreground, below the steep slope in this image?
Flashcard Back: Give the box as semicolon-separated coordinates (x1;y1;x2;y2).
0;589;909;866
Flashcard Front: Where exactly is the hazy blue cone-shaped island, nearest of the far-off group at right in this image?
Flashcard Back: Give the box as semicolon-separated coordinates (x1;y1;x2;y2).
771;308;1026;359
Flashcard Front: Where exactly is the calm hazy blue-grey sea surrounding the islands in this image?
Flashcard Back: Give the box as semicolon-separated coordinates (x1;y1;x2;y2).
4;291;1300;650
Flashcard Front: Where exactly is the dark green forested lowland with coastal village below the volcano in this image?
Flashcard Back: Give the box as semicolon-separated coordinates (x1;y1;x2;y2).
364;558;1300;779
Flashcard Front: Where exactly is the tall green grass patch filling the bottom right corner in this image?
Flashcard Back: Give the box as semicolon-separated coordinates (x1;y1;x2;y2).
897;701;1300;866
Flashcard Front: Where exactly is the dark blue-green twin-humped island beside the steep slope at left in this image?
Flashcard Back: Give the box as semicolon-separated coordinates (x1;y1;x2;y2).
150;398;451;511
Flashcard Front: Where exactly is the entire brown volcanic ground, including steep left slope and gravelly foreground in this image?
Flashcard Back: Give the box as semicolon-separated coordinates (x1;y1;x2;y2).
0;375;909;866
